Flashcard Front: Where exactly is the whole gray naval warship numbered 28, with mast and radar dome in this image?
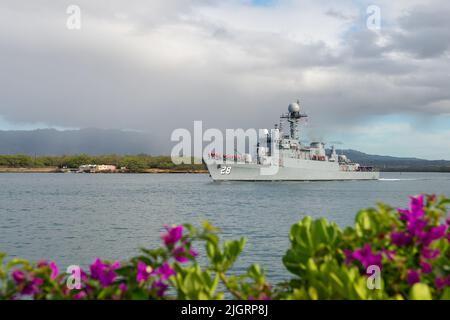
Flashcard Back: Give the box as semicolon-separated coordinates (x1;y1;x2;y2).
203;100;380;181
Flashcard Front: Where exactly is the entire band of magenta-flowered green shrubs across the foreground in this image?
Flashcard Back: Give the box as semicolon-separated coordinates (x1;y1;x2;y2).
0;195;450;299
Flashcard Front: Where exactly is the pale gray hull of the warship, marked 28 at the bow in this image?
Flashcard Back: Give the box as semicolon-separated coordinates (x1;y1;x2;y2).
206;160;380;181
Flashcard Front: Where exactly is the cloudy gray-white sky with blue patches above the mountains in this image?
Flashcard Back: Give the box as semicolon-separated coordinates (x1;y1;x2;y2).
0;0;450;159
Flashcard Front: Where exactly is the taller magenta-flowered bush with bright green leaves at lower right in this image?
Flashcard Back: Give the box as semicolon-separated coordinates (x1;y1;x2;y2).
283;195;450;299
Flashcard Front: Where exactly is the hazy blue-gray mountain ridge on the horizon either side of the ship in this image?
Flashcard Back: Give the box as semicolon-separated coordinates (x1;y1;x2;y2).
0;128;450;172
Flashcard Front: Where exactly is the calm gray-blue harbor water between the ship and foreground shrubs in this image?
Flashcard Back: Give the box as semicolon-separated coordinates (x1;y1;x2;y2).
0;173;450;281
